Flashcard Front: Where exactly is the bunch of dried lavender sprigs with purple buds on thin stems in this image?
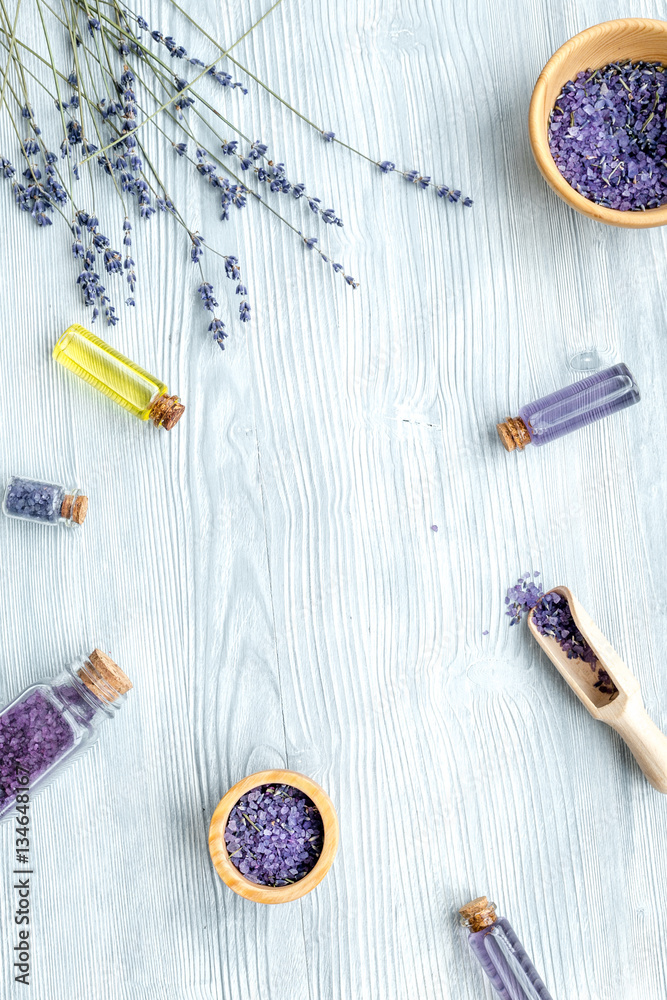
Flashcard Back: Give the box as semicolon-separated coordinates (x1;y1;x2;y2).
0;0;472;347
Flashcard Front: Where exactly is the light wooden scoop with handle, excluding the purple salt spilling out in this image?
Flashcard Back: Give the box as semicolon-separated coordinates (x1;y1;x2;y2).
528;587;667;793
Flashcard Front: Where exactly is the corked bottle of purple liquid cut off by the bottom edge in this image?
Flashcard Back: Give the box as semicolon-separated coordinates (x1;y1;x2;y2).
459;896;553;1000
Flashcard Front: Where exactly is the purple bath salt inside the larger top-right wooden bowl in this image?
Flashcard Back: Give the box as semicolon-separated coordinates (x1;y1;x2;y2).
549;61;667;212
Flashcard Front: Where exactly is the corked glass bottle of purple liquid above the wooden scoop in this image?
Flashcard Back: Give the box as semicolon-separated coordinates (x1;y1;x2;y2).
496;364;641;451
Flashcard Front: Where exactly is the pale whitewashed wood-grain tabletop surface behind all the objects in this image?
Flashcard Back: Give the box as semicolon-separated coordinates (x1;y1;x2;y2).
0;0;667;1000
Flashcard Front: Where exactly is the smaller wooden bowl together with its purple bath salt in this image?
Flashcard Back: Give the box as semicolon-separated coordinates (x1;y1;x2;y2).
208;770;338;903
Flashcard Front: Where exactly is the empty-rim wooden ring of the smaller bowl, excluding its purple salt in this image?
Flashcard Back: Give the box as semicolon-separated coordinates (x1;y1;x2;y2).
208;771;338;903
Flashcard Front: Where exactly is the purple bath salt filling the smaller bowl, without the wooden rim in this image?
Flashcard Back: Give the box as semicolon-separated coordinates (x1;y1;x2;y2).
225;785;324;886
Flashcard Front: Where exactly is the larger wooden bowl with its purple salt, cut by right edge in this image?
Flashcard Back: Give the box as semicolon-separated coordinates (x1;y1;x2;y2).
528;17;667;229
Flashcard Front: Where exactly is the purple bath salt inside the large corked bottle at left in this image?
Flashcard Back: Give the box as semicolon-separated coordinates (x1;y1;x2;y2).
0;688;74;812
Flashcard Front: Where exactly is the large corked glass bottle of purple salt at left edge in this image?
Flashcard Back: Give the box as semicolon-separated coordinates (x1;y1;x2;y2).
0;649;132;817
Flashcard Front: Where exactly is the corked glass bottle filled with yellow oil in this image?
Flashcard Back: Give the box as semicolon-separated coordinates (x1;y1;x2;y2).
53;324;185;431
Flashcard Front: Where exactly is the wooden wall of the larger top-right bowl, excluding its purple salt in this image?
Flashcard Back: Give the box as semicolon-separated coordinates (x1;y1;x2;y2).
528;17;667;229
